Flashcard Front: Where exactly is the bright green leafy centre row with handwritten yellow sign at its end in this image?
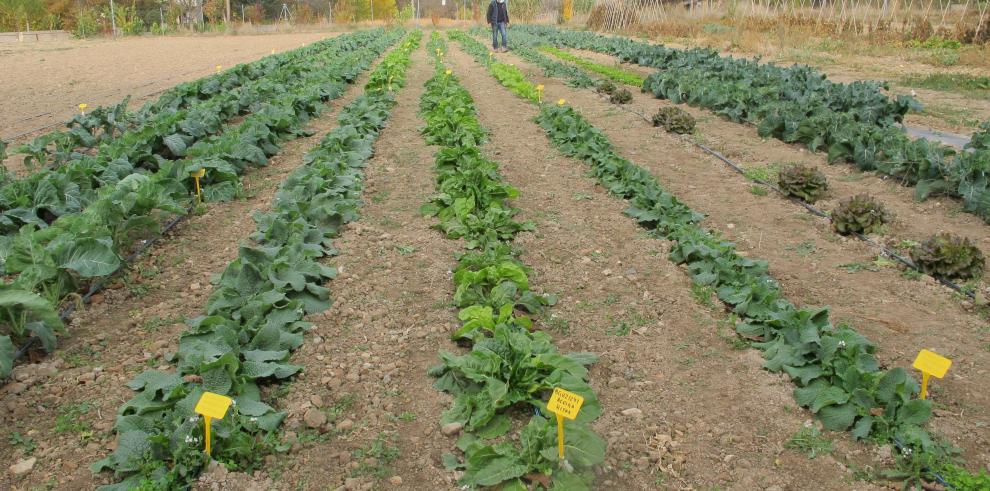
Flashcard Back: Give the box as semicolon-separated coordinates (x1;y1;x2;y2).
420;33;605;490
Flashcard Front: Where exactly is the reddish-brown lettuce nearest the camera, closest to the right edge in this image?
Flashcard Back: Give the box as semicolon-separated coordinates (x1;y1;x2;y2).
911;232;986;280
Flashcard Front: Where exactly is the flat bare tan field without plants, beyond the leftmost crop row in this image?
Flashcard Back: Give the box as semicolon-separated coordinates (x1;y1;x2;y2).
0;32;337;141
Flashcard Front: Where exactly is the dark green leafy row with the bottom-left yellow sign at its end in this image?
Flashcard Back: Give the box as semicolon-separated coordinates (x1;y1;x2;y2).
91;31;421;490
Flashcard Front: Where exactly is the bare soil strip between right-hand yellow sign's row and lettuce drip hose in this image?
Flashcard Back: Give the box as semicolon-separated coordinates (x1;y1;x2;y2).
492;45;990;472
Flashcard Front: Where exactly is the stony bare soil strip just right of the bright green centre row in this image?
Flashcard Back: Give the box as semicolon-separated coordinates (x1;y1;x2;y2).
447;44;888;490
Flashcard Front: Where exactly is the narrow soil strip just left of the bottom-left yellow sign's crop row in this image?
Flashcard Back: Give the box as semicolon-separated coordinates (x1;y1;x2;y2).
0;55;374;489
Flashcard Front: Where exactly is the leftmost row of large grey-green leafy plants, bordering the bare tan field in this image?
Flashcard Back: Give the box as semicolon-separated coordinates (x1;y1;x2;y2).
0;33;381;235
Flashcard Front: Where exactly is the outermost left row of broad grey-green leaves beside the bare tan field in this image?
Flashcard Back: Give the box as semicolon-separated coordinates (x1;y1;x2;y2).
0;31;392;236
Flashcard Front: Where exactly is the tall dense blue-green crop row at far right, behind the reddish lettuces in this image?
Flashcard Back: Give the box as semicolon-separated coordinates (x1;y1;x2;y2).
520;26;990;229
